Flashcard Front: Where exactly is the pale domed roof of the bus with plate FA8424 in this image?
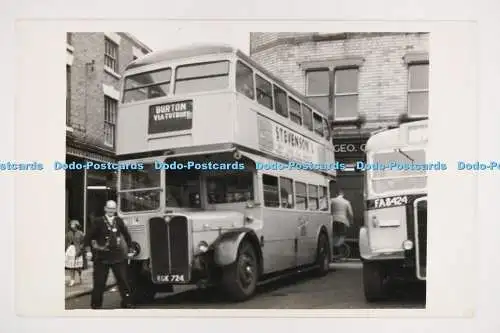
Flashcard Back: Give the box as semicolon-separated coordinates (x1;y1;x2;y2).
365;120;428;151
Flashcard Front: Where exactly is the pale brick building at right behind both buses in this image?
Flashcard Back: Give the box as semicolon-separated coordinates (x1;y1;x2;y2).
250;32;429;249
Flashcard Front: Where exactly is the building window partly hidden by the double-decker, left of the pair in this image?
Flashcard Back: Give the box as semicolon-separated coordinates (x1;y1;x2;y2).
306;69;330;114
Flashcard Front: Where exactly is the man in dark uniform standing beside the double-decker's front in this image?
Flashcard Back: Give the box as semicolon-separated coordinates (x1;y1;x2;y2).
85;200;132;309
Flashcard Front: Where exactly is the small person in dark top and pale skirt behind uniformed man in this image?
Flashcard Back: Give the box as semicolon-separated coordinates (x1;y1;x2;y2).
65;220;87;287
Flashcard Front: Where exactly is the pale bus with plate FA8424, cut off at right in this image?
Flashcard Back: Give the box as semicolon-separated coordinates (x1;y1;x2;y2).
359;120;430;302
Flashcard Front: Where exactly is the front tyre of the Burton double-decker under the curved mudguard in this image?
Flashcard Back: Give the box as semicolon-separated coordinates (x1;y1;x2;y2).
222;240;259;302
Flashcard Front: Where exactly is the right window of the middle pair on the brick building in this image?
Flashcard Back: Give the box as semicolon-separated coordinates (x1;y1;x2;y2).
333;68;358;120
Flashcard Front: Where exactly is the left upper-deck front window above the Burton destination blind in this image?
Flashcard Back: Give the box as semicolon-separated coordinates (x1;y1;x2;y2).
123;68;172;103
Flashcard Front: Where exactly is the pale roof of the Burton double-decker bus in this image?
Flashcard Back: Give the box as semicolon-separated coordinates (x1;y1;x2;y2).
125;44;326;116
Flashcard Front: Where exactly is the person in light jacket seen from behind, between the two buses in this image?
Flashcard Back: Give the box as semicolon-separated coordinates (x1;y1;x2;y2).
331;190;354;252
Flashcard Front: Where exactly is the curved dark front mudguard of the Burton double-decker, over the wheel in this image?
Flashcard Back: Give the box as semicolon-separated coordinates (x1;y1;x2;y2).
213;229;260;266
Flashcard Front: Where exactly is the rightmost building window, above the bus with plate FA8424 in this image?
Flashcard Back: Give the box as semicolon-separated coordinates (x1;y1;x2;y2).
408;63;429;117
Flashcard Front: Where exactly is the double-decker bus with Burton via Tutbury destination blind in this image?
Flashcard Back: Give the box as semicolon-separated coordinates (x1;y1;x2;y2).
116;45;336;302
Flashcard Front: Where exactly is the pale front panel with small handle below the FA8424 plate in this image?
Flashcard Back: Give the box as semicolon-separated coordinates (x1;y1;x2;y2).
365;206;407;251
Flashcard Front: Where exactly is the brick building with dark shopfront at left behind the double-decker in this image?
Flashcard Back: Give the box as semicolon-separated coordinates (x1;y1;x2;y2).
66;32;151;229
